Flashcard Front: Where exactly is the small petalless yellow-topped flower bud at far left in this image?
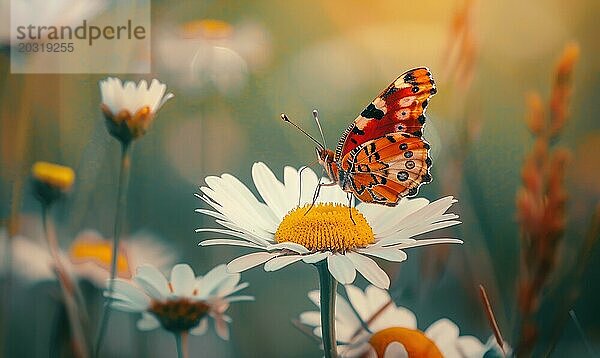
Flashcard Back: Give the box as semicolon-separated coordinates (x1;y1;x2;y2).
31;162;75;204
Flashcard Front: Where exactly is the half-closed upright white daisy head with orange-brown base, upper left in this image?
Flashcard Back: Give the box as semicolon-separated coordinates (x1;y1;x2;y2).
100;77;174;142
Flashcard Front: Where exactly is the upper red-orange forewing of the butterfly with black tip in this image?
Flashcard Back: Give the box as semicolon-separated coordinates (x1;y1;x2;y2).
335;67;437;162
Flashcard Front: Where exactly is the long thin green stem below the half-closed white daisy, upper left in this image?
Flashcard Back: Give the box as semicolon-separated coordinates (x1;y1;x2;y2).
94;142;131;357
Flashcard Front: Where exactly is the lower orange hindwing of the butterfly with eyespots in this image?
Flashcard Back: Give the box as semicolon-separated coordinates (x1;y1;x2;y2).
341;132;431;206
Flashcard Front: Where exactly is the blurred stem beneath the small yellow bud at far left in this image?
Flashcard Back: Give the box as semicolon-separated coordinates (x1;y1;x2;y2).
42;204;89;358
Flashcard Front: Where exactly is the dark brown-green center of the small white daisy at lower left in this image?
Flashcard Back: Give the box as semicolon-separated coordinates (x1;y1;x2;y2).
148;298;210;332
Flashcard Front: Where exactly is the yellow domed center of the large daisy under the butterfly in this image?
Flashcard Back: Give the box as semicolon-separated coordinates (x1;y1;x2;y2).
275;204;375;252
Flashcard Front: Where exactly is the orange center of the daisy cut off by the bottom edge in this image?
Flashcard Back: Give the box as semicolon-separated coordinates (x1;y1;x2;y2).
369;327;443;358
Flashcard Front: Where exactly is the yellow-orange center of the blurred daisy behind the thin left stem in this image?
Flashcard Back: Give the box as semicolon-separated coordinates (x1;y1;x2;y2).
69;240;131;278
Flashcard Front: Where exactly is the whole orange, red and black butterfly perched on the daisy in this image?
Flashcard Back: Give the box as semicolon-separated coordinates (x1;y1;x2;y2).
282;67;437;206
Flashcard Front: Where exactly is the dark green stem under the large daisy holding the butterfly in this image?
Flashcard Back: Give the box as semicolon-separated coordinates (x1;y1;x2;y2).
315;260;337;358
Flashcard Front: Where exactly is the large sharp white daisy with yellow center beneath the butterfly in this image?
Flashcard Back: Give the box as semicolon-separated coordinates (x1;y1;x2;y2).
196;163;462;288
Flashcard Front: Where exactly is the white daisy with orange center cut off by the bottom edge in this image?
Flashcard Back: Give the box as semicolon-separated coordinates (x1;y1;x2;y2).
300;285;496;358
